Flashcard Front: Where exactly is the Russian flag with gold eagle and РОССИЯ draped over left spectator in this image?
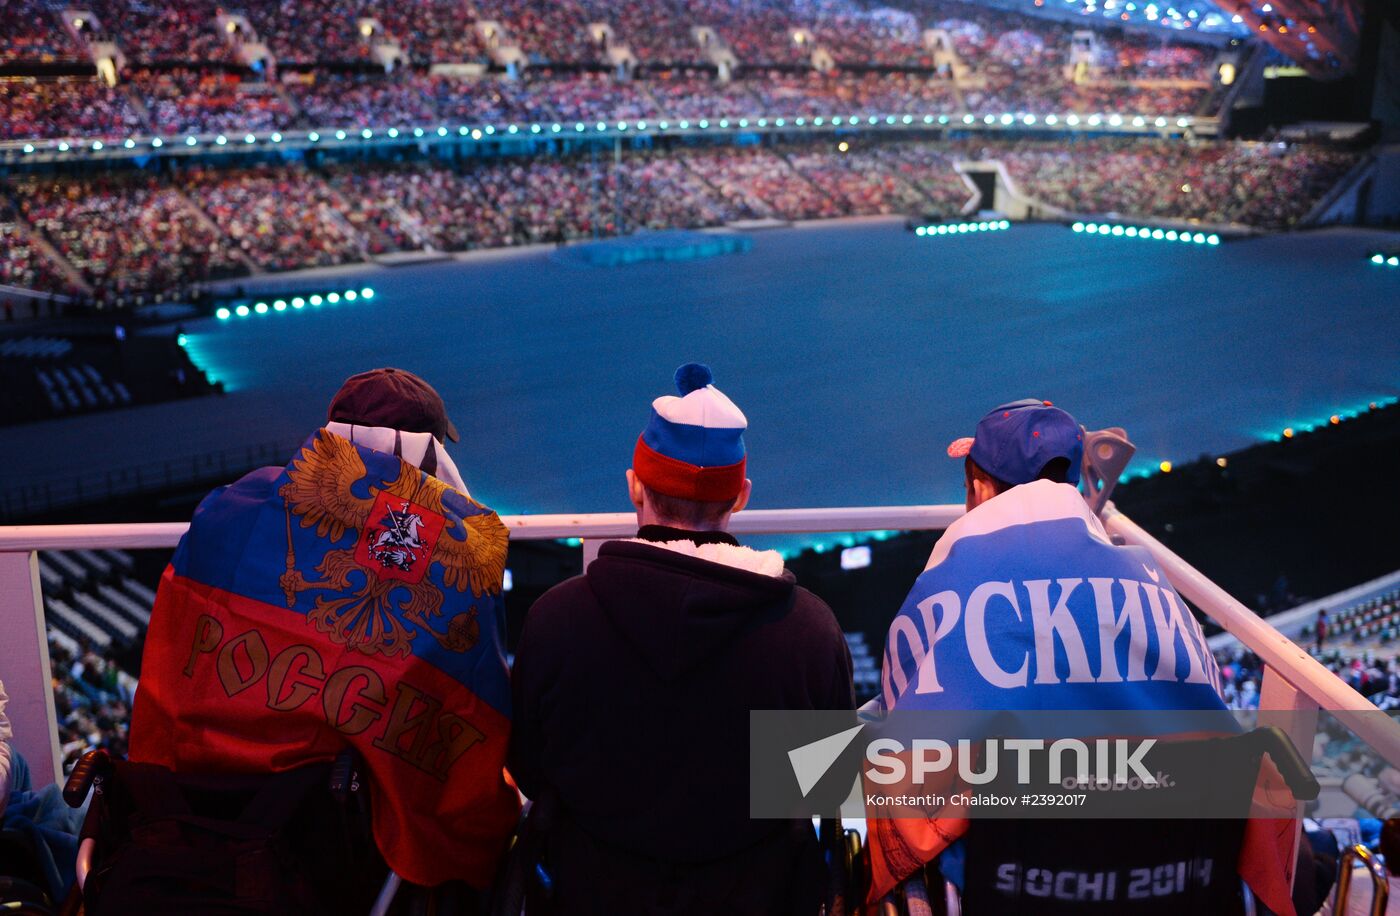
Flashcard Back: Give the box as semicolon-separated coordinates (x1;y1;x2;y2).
130;430;519;887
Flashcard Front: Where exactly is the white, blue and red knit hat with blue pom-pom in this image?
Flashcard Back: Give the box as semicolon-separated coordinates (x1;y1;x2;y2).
631;363;749;503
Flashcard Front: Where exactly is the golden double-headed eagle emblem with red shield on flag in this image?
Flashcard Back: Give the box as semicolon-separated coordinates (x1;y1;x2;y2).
279;430;510;655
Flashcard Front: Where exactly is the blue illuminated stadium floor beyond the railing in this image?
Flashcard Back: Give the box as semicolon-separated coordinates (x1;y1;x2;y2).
4;221;1400;532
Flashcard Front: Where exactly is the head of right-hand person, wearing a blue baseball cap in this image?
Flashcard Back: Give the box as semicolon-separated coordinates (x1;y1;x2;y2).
948;398;1084;511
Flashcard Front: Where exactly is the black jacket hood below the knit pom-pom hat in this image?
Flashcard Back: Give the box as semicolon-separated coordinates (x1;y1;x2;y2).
585;541;797;681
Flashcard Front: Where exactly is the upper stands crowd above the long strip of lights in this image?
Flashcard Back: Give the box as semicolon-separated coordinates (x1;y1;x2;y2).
0;0;1211;139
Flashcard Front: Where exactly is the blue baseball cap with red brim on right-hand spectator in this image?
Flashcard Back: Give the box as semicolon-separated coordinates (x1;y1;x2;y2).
948;398;1084;486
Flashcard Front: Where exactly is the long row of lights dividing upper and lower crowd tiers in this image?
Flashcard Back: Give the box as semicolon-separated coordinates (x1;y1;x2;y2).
10;112;1191;154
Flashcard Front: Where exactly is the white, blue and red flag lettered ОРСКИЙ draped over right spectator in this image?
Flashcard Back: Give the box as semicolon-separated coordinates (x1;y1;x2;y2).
869;480;1292;913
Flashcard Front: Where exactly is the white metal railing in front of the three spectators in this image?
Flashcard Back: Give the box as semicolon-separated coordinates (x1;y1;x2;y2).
0;503;1400;783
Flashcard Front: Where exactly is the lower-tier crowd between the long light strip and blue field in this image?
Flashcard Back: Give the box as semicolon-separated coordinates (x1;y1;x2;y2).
0;137;1355;300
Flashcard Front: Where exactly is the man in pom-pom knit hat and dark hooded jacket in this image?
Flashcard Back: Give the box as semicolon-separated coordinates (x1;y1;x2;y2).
508;364;853;916
